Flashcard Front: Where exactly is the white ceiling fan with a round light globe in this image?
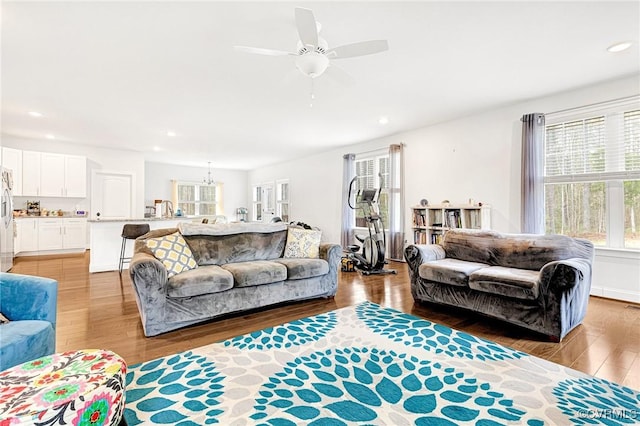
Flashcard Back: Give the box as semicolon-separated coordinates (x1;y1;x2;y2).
235;7;389;78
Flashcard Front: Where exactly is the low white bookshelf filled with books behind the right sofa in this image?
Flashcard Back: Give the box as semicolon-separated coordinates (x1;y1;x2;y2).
411;204;491;244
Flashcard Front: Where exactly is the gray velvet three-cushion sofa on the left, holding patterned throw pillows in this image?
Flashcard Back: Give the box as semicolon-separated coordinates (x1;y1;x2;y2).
129;223;342;336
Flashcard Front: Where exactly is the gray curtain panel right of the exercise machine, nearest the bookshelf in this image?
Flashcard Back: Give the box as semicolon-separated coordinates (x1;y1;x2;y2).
388;144;404;260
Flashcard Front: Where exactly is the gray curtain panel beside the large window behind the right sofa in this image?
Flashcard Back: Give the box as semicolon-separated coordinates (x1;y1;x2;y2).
520;113;545;234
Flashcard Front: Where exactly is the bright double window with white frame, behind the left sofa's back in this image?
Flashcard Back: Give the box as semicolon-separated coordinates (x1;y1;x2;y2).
175;182;222;216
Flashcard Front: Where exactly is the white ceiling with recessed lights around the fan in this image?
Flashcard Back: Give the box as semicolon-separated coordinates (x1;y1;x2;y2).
1;1;640;169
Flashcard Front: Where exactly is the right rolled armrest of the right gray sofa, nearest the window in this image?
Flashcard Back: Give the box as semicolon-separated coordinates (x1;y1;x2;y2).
540;258;591;292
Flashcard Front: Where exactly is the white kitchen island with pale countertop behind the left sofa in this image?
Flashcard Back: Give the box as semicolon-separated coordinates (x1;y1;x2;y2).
89;217;193;272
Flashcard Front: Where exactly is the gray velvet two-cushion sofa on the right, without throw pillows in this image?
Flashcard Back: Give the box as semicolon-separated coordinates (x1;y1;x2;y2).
405;230;594;341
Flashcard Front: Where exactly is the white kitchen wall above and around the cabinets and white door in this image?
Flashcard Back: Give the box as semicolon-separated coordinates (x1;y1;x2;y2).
2;135;145;217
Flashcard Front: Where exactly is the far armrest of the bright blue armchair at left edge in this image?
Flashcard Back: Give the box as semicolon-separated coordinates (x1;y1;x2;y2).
0;272;58;329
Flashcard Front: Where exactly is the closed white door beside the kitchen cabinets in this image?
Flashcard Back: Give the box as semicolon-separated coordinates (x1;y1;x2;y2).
91;170;134;219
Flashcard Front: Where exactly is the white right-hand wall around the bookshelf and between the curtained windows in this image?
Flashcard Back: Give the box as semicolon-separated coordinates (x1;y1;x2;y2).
249;75;640;302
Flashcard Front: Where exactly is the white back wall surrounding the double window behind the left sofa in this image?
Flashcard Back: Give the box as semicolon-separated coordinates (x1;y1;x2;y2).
144;162;248;220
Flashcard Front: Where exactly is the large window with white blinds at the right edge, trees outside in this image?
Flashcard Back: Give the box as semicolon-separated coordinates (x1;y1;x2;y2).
544;100;640;249
